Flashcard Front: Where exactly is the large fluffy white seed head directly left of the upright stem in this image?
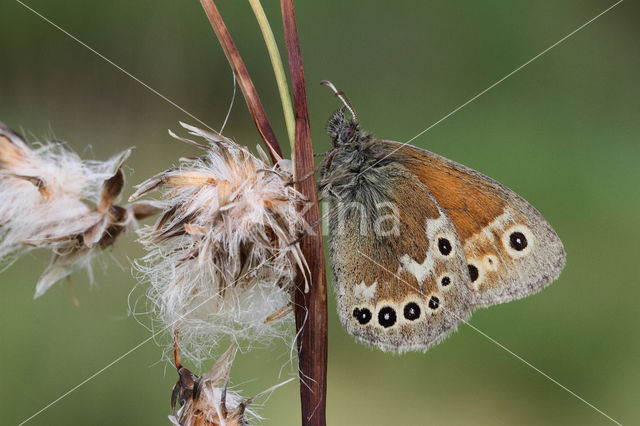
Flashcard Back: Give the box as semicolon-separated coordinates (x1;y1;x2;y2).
131;124;307;362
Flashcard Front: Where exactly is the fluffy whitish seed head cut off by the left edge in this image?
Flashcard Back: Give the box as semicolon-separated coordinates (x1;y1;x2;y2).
0;123;157;297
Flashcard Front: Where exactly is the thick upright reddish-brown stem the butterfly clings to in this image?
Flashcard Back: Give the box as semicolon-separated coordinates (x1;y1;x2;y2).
280;0;328;425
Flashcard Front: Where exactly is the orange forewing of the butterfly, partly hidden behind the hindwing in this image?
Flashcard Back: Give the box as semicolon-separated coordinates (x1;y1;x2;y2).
396;141;565;306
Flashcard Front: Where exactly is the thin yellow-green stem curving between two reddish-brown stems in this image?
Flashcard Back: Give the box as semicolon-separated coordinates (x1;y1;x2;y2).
249;0;296;152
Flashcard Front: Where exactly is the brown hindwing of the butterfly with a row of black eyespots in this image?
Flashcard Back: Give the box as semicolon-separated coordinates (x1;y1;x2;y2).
329;159;472;351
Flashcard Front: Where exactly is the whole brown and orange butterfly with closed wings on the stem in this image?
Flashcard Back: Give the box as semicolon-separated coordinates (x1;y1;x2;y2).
318;82;565;352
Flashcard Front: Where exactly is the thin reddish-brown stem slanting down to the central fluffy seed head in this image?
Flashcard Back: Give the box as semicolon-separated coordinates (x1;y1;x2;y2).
200;0;282;163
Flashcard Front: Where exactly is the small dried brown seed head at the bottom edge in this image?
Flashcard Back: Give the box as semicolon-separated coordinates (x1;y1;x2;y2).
169;345;293;426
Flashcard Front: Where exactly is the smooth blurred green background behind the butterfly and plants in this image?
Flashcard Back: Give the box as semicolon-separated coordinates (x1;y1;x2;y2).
0;0;640;425
